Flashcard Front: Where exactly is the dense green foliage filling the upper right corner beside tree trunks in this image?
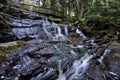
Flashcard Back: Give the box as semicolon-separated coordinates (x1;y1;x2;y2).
79;0;120;30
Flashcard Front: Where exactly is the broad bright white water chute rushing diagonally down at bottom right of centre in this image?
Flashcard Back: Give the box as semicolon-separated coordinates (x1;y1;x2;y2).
66;53;94;80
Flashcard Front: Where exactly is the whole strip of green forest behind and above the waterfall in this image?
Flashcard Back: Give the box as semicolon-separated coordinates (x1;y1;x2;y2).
9;0;120;30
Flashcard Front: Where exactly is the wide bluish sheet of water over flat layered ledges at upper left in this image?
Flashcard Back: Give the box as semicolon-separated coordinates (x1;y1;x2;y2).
11;19;41;39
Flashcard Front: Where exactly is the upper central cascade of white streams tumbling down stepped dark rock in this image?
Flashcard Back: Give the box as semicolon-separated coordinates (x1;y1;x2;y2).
43;19;67;41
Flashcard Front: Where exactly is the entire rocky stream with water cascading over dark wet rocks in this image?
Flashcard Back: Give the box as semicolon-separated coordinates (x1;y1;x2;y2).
0;8;120;80
